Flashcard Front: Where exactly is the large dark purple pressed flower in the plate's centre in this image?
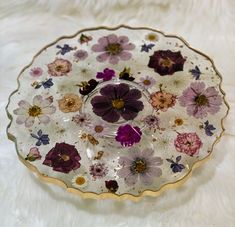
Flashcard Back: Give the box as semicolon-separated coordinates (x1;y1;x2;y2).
91;83;144;122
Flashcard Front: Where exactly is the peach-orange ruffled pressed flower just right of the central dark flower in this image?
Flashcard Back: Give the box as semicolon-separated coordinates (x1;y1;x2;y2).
150;91;176;112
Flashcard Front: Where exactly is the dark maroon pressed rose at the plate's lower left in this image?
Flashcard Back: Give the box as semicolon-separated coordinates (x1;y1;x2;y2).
43;143;81;173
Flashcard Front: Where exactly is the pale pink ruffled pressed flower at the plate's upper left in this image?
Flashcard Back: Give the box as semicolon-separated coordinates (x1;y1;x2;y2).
47;58;72;77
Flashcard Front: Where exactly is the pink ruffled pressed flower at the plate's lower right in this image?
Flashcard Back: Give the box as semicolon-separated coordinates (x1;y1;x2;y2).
174;132;202;156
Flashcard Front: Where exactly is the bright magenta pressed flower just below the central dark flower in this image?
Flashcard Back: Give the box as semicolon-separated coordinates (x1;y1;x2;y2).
115;124;142;146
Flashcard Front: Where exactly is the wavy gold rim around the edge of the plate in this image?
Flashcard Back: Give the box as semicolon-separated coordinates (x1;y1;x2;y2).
5;25;230;201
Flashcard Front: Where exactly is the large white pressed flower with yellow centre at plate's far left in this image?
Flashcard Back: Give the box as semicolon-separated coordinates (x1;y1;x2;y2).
13;95;56;127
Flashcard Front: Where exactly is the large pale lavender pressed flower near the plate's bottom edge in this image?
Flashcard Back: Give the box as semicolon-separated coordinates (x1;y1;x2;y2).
117;147;163;186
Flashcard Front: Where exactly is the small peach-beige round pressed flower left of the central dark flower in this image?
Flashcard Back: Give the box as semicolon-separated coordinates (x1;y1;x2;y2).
58;93;82;113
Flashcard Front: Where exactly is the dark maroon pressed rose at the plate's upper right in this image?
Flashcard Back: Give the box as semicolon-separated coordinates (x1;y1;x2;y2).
148;50;186;76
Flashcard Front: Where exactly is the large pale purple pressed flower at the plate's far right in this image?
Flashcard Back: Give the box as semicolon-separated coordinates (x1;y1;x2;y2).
179;82;222;118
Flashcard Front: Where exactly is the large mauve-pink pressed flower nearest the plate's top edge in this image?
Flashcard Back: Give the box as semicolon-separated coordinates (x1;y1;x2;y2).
91;34;135;64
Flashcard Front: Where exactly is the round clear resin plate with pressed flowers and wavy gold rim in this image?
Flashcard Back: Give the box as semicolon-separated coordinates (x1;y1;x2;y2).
7;26;228;199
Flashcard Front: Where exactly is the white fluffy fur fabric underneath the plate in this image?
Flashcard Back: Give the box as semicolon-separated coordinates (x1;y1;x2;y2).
0;0;235;227
